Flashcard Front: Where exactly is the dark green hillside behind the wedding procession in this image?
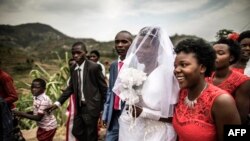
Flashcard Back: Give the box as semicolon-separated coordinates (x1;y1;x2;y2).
0;23;195;72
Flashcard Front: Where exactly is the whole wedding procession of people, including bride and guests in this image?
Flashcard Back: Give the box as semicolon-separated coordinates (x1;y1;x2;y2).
0;27;250;141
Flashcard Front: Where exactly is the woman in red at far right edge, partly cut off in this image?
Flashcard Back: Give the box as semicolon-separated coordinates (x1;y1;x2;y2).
231;30;250;76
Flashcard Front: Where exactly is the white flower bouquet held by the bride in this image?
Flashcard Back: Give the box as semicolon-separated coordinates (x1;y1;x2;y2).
118;68;147;105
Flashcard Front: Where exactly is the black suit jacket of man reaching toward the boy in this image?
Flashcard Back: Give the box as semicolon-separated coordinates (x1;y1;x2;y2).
58;60;107;117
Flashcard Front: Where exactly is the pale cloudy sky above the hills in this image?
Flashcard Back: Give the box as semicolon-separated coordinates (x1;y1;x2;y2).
0;0;250;41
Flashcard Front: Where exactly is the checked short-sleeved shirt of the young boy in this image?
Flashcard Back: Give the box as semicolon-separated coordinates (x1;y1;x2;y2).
33;93;57;131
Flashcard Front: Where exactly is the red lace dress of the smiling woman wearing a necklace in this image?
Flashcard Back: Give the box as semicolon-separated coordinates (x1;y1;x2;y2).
173;84;227;141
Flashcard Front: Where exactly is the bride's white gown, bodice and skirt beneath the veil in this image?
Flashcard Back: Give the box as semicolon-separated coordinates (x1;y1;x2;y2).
119;67;176;141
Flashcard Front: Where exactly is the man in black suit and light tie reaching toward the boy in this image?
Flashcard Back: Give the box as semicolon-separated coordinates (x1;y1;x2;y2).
46;42;107;141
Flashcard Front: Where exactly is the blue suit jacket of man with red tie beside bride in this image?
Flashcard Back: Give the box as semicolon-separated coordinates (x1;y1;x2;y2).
102;60;125;129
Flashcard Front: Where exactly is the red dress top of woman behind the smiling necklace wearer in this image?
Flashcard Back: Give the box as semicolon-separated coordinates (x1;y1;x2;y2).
206;71;250;96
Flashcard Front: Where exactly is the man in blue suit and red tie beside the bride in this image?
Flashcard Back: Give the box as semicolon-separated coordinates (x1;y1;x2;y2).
102;30;133;141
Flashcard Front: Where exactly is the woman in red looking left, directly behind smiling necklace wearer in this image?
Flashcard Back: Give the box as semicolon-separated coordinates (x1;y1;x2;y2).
207;39;250;124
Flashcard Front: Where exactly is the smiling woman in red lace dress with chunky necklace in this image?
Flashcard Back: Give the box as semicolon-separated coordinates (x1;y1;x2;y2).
173;39;241;141
